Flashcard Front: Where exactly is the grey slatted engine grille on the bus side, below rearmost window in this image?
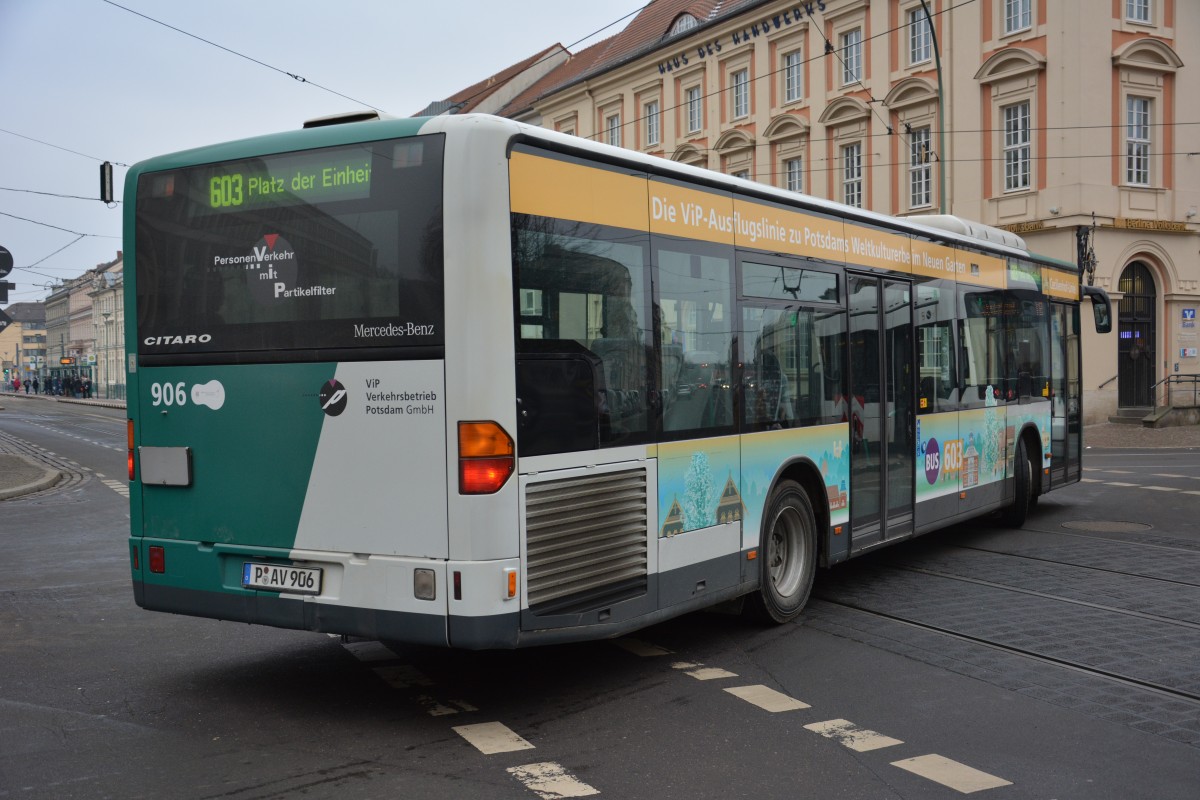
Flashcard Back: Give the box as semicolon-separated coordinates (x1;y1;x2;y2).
526;469;648;614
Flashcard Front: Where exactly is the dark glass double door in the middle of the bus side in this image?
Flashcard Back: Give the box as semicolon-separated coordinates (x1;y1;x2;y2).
847;276;916;552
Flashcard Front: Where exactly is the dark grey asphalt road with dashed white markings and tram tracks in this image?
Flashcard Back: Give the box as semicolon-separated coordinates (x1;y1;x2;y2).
0;403;1200;800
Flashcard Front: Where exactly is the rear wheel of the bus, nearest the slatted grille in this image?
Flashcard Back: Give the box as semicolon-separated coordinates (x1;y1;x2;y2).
750;481;817;622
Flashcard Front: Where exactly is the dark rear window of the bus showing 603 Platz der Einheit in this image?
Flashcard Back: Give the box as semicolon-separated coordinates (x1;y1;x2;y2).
134;136;445;360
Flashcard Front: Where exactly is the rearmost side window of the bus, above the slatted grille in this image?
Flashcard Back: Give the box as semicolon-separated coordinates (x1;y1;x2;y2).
512;217;653;455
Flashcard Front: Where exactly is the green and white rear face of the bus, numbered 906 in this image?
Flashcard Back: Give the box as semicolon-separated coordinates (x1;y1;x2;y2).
125;120;477;644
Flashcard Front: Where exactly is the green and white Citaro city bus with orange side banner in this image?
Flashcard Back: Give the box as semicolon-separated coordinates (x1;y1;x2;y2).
125;115;1108;648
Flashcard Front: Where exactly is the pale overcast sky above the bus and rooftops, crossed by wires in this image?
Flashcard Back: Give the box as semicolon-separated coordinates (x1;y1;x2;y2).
0;0;646;302
